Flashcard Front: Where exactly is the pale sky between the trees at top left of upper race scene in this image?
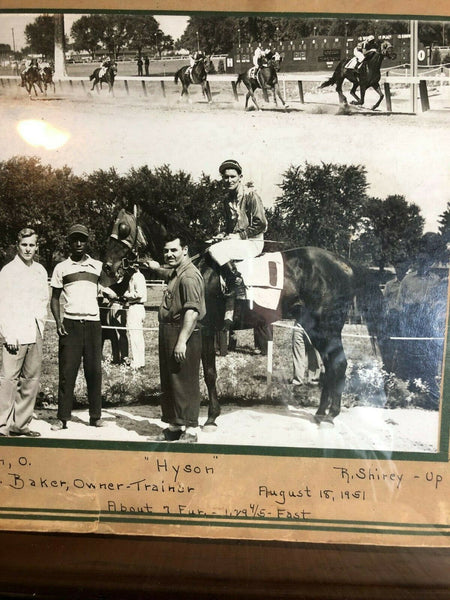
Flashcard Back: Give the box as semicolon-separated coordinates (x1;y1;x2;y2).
0;13;189;50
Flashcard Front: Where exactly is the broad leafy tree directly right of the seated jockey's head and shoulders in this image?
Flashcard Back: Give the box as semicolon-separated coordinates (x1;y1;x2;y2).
268;163;367;256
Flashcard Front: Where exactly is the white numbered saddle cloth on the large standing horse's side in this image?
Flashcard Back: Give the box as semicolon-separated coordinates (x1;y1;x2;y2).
223;252;284;310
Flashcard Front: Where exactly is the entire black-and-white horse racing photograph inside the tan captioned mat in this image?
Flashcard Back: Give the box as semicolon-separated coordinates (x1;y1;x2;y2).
0;11;450;460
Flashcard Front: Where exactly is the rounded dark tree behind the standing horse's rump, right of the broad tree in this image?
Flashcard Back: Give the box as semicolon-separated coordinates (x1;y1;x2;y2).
354;195;425;270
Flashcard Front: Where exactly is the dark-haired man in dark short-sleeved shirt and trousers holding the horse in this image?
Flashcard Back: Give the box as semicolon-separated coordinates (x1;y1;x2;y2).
158;236;206;442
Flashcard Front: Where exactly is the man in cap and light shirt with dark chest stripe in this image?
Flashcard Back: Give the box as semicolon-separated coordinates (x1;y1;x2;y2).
50;224;110;431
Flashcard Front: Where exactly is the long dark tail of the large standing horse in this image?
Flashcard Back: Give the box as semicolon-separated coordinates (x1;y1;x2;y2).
353;266;384;352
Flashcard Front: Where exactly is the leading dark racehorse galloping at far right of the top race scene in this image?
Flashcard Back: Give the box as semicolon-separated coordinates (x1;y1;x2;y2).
319;41;396;110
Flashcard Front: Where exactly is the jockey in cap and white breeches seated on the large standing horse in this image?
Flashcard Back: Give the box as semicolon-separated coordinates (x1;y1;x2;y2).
208;159;267;321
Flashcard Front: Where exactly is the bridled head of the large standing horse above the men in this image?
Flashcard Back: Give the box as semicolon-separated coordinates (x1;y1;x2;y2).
103;209;138;280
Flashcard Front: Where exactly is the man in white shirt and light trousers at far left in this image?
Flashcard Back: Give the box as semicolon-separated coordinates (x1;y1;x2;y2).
0;228;48;437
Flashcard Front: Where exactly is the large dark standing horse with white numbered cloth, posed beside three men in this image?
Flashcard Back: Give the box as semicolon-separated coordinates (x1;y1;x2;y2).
103;211;383;428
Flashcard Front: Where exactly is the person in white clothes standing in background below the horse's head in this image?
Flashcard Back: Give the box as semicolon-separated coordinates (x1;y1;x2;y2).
124;263;147;369
